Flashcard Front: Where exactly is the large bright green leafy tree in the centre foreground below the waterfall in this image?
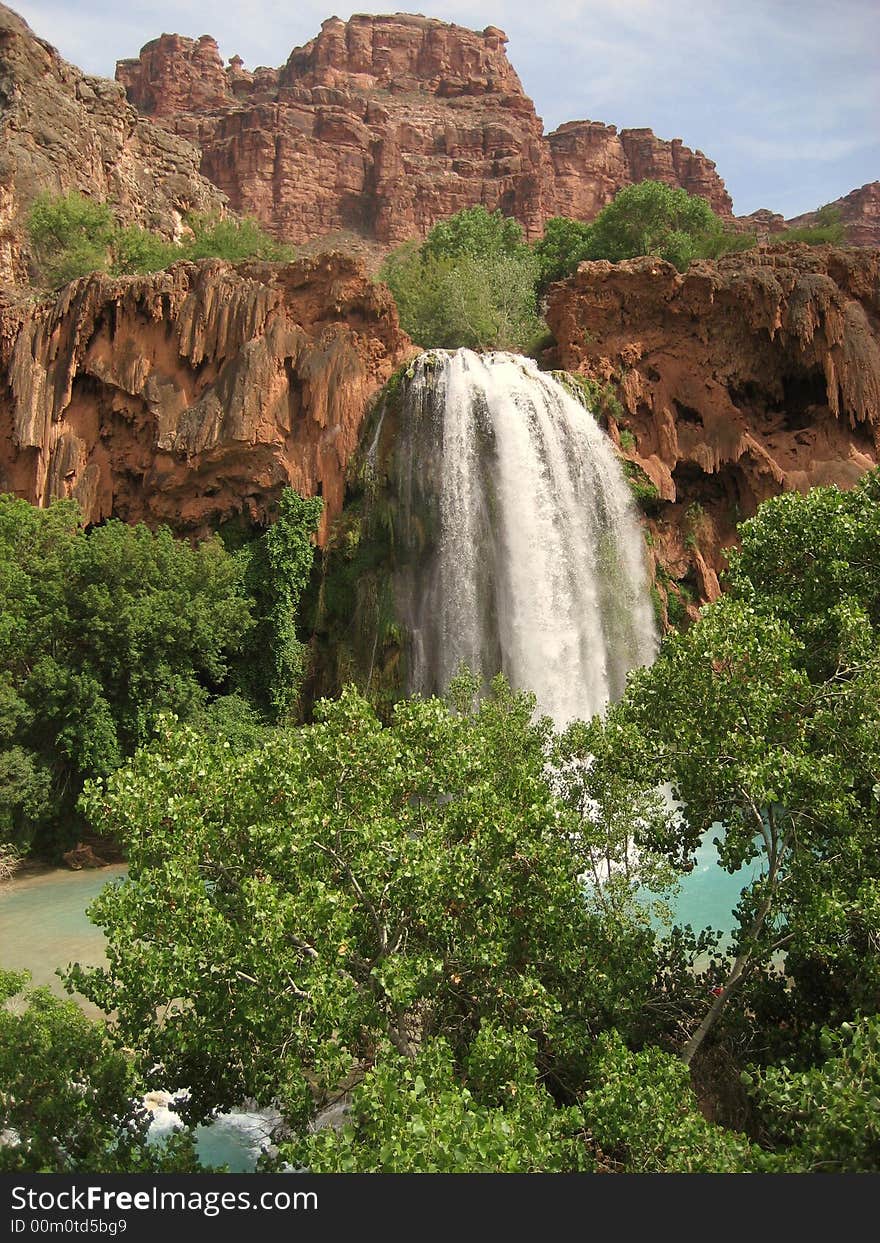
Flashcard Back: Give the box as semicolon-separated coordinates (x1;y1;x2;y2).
68;681;653;1120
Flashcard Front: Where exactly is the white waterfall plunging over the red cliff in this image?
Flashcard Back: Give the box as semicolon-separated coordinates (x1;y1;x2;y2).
396;349;656;726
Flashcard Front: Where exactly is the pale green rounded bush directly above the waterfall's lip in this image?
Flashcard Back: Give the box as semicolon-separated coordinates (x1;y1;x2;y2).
380;208;543;349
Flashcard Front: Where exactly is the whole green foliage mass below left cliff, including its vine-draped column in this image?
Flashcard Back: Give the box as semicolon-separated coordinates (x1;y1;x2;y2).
0;488;322;851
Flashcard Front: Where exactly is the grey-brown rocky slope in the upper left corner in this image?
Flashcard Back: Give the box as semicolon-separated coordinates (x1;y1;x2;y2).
0;5;225;283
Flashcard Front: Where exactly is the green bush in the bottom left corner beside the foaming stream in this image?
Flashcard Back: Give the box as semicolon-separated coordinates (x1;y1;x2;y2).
0;971;200;1173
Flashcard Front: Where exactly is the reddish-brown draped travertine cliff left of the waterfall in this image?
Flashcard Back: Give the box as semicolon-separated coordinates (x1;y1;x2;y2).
0;255;411;537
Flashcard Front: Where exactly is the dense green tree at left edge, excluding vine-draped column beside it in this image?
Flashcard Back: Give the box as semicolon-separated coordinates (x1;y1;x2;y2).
0;496;251;846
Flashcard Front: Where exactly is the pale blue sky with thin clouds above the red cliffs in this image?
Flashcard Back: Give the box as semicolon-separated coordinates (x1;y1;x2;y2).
10;0;880;216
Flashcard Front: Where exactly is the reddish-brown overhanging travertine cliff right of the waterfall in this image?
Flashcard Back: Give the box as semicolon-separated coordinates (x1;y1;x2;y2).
547;245;880;611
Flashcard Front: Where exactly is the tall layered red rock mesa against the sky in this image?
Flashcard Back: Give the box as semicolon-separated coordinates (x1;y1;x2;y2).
117;14;732;244
